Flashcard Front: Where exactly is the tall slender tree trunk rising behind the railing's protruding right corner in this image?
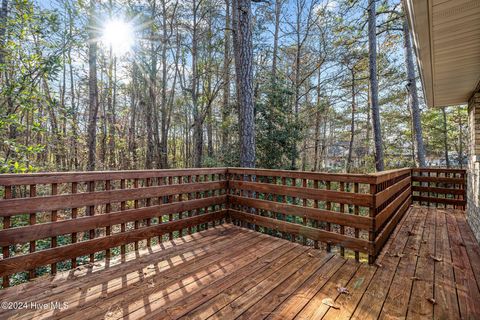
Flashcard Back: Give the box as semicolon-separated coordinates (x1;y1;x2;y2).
368;0;384;171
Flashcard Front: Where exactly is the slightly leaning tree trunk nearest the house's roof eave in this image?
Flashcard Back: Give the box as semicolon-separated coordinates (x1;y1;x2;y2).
403;17;426;167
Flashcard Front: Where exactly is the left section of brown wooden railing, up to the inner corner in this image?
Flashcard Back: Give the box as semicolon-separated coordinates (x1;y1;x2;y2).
0;168;227;287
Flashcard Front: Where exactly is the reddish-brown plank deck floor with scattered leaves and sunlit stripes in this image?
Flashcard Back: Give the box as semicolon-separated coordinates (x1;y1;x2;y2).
0;207;480;319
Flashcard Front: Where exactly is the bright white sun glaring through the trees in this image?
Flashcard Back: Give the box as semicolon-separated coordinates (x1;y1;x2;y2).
102;19;134;55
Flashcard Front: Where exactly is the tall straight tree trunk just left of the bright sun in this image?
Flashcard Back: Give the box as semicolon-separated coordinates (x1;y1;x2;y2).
87;0;98;171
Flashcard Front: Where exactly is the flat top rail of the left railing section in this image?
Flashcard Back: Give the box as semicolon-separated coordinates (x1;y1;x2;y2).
0;167;227;186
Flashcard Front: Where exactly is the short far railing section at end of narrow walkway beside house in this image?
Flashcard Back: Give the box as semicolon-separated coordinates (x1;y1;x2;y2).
412;168;467;209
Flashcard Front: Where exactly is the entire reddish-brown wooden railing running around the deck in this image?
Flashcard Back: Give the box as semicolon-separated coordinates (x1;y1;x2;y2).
0;168;465;287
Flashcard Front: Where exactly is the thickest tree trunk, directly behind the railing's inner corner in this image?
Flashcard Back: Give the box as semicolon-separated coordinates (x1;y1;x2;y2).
234;0;255;168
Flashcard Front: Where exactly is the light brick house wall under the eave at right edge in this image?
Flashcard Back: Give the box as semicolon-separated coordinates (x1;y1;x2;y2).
467;92;480;243
